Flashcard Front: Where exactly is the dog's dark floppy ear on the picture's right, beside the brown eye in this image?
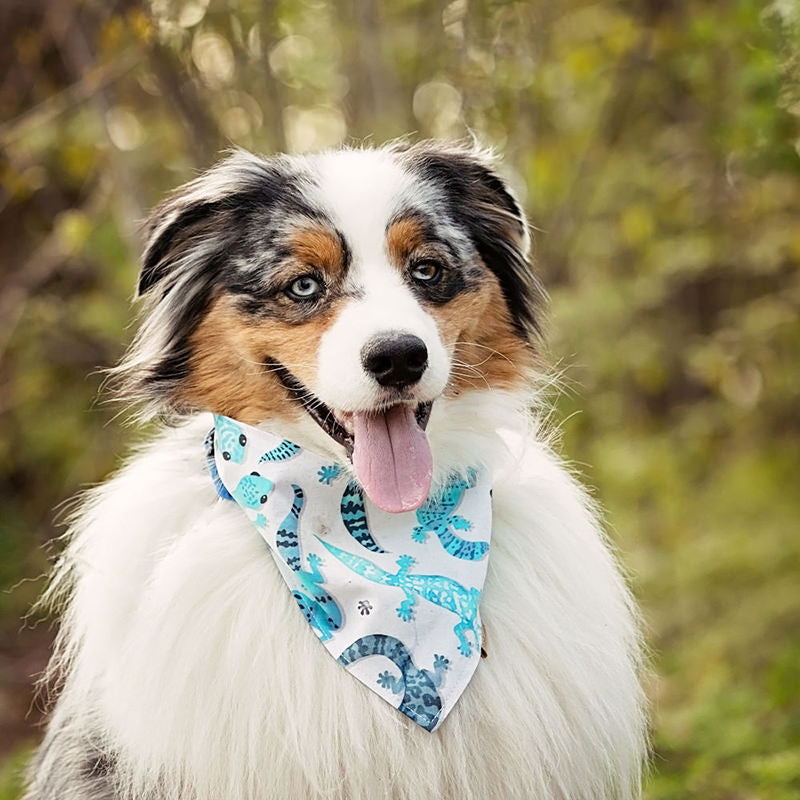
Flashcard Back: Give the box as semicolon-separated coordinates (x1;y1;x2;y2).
398;141;545;340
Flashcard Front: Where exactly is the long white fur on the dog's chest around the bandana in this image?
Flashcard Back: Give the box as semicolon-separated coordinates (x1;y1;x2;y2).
50;412;645;800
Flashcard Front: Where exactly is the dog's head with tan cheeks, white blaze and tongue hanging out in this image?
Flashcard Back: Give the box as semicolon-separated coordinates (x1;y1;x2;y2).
121;143;540;511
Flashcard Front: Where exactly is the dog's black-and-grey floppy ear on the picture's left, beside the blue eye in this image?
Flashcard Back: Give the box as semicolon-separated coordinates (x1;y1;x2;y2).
117;151;290;419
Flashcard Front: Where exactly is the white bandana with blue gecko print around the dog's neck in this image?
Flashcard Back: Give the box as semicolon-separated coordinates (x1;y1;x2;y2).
206;415;492;731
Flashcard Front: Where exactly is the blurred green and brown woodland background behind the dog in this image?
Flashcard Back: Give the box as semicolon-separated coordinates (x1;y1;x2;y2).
0;0;800;800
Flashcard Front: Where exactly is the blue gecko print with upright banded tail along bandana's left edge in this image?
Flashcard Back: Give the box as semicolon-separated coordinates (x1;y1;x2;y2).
275;484;342;642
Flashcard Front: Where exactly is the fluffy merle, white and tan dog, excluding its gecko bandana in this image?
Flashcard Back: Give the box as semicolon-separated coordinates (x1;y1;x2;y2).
25;142;647;800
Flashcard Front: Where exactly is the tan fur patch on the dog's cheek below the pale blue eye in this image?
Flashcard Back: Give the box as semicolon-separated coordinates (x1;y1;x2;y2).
179;295;336;425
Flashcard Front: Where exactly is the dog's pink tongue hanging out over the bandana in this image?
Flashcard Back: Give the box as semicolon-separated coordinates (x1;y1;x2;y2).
353;405;433;514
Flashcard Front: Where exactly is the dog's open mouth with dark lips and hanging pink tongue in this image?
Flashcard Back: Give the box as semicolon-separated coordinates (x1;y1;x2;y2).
266;360;433;513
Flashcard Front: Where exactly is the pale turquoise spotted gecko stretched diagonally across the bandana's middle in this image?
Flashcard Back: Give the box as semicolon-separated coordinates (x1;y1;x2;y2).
317;536;481;656
